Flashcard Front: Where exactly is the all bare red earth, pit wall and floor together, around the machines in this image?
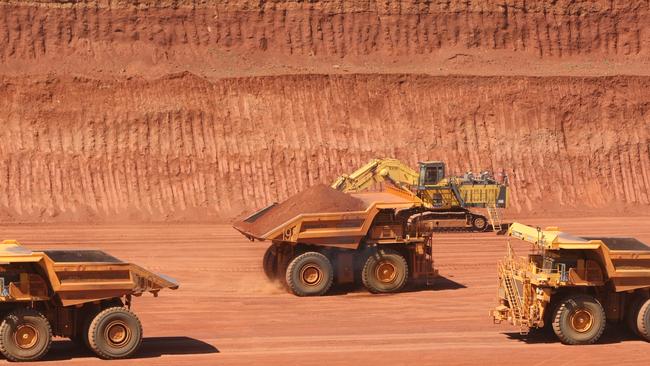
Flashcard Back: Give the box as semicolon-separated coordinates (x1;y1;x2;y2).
0;0;650;365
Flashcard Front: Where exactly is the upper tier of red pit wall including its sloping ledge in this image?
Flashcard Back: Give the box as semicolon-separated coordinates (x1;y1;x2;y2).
0;0;650;76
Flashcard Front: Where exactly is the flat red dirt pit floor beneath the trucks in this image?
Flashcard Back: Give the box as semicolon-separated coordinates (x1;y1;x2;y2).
0;217;650;365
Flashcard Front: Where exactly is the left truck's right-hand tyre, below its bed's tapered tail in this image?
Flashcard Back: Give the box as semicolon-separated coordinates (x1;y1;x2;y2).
88;307;142;360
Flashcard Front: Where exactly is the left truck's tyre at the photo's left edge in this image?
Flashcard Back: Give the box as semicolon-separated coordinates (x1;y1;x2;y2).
0;309;52;362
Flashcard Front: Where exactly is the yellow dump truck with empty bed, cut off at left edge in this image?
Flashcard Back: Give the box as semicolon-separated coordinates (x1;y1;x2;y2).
0;240;178;361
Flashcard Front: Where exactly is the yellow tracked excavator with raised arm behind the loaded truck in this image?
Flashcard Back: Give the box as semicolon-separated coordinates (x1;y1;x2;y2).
331;158;508;233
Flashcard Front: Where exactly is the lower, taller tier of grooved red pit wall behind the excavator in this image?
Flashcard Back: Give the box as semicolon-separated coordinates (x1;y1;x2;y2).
0;73;650;222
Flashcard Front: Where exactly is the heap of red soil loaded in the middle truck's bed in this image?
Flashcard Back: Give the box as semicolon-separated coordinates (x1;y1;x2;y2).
234;184;365;236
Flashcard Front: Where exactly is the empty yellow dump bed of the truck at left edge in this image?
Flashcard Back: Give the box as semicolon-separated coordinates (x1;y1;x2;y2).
0;240;178;306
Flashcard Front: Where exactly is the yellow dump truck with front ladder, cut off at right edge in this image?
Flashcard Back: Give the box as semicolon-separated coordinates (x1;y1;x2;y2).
491;223;650;344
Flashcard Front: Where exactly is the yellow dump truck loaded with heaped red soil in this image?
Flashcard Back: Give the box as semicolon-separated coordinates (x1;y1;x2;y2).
233;185;436;296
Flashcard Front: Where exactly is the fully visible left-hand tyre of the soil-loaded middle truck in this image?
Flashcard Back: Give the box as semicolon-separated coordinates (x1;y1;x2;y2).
286;252;334;296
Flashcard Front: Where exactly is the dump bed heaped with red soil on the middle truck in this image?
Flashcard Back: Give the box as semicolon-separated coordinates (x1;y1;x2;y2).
233;185;422;248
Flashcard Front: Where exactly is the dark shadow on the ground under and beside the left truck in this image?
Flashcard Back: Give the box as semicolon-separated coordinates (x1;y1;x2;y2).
42;337;219;361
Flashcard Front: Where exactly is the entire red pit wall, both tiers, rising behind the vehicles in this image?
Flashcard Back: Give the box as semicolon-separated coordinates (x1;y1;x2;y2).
0;0;650;222
